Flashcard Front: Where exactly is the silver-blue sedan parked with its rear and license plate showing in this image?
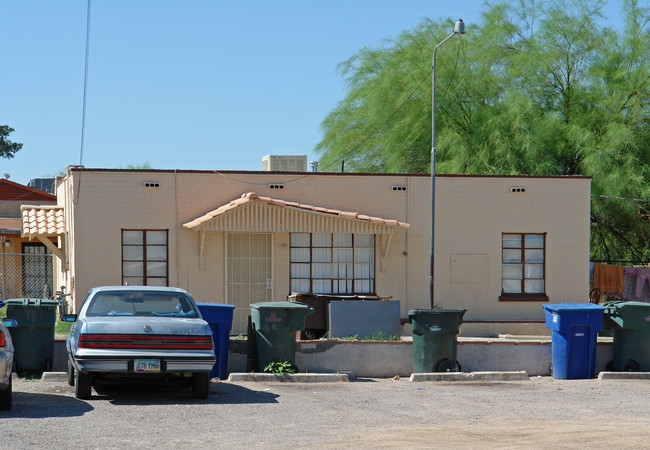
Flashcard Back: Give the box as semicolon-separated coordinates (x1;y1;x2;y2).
63;286;216;399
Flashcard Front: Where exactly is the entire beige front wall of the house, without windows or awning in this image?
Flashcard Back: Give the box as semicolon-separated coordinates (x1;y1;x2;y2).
57;169;590;326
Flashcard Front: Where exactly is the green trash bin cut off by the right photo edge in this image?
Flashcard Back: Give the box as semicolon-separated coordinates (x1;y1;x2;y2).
602;301;650;372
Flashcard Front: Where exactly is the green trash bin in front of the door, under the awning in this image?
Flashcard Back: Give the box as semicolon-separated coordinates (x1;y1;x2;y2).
251;302;314;372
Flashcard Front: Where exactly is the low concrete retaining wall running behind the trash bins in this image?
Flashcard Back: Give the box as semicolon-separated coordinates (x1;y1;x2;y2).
53;337;613;378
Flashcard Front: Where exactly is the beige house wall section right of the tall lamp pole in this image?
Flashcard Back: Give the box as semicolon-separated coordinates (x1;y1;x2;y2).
434;177;590;320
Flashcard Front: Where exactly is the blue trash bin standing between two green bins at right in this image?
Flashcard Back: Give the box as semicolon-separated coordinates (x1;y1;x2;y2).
544;303;605;379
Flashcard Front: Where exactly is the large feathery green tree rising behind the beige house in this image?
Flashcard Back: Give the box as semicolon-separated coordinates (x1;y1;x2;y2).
316;0;650;261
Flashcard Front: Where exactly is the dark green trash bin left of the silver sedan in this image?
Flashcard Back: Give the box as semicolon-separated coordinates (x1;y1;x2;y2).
5;298;59;372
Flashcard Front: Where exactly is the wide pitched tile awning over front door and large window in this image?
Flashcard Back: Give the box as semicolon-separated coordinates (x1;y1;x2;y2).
183;192;409;234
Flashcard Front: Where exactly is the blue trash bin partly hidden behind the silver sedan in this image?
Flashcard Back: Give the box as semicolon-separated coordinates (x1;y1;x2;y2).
196;303;235;380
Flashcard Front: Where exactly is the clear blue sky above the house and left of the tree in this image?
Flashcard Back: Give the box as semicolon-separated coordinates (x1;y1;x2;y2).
0;0;618;184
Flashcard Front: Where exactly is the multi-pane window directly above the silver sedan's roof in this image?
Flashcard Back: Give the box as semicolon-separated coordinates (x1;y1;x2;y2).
122;230;168;286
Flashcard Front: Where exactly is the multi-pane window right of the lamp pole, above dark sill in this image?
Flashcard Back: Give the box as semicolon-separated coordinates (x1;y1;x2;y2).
501;233;546;296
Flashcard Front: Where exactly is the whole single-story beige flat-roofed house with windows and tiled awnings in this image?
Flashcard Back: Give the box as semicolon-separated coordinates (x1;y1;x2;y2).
23;167;591;334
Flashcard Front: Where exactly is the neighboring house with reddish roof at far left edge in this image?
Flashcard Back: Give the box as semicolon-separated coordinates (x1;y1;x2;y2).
0;178;56;300
